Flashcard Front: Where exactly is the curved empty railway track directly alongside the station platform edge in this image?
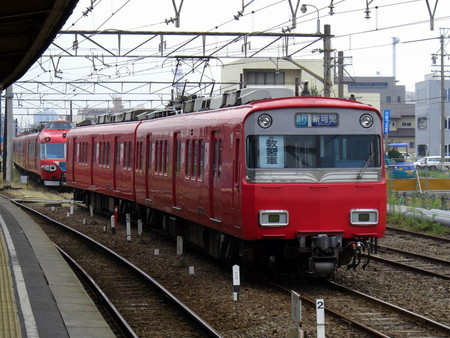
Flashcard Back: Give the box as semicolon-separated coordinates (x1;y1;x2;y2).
13;201;221;337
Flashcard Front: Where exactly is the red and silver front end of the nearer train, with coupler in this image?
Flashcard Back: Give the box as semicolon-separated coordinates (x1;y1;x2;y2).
236;98;386;275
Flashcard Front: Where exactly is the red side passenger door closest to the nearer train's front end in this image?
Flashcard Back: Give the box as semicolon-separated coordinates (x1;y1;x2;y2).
209;130;222;222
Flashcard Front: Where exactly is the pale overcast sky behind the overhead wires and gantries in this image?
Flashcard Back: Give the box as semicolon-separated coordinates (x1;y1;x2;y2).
10;0;450;125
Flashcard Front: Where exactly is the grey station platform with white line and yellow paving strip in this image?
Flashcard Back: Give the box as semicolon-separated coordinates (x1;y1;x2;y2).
0;196;115;338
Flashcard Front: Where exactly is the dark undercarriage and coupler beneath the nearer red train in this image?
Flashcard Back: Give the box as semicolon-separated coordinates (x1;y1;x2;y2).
75;189;375;278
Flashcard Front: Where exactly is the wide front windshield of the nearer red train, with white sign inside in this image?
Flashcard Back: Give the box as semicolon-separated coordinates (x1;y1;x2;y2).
247;135;381;169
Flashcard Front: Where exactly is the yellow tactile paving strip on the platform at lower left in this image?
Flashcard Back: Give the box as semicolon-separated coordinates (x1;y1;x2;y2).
0;228;22;338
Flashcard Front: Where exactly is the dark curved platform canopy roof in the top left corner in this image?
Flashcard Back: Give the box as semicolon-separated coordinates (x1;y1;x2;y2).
0;0;78;90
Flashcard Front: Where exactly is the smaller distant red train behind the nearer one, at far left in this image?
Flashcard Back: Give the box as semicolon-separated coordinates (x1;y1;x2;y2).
13;121;74;186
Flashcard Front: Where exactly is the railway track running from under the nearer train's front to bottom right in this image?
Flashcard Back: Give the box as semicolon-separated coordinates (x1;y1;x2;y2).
275;282;450;337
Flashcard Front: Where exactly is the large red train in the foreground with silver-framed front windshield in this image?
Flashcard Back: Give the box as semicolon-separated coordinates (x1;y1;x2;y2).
67;89;386;277
